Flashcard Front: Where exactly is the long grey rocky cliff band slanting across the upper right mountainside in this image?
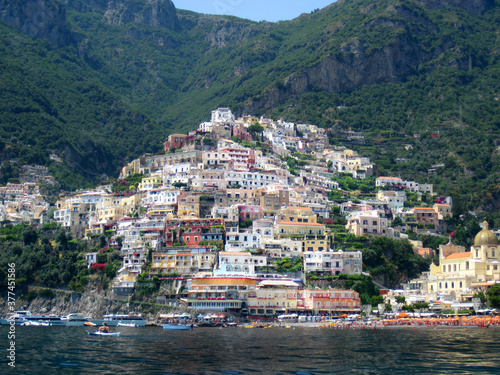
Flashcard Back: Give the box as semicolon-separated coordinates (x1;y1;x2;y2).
244;0;491;113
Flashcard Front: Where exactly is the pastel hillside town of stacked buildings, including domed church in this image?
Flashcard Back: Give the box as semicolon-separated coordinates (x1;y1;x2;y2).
0;108;500;316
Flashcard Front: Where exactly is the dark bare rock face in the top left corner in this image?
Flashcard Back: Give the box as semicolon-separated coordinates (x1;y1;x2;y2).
0;0;74;47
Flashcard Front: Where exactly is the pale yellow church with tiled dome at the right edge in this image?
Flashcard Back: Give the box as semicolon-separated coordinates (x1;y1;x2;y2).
426;221;500;299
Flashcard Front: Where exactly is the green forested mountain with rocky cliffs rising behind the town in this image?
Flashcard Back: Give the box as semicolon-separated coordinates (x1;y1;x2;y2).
0;0;500;217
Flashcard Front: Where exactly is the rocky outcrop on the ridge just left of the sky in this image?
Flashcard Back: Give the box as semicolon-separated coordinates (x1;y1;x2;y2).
103;0;179;30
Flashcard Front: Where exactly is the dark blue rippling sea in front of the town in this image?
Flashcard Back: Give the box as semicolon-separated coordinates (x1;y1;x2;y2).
0;326;500;375
